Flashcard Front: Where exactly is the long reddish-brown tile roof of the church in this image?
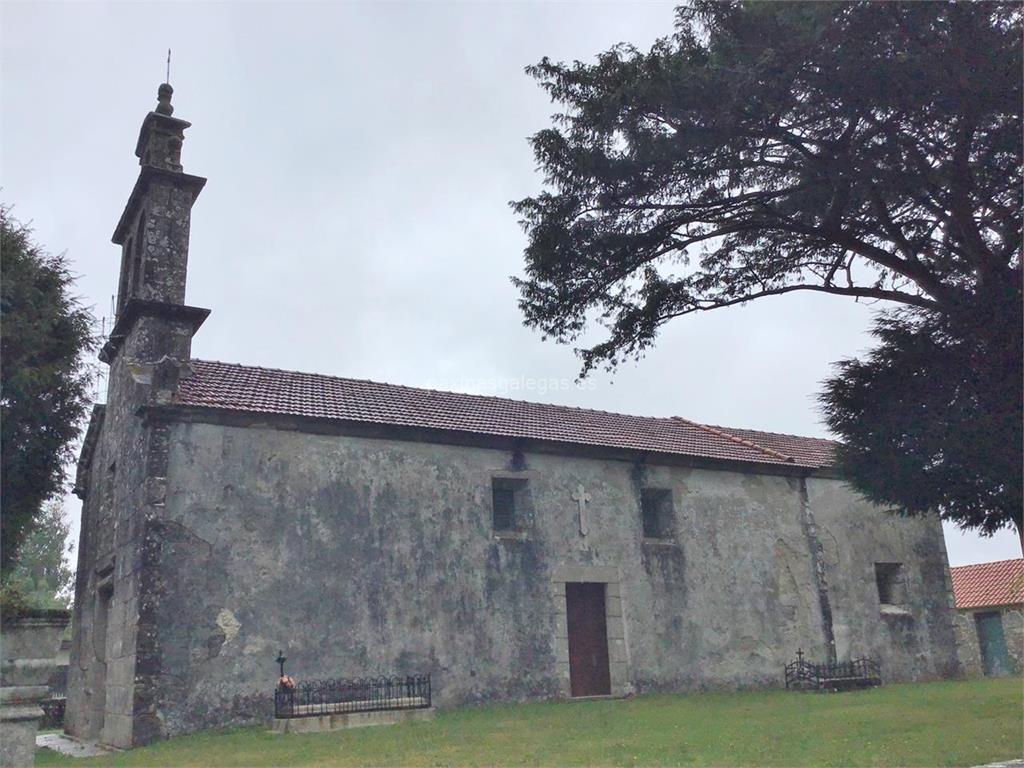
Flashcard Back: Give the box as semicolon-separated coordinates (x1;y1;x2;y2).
177;360;834;469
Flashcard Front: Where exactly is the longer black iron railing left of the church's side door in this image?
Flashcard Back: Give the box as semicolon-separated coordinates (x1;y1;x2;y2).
273;675;430;718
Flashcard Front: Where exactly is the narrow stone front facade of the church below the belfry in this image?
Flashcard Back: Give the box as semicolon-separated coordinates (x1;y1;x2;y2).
66;229;205;748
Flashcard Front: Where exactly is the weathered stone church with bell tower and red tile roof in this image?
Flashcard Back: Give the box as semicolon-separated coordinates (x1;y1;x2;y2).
67;85;957;748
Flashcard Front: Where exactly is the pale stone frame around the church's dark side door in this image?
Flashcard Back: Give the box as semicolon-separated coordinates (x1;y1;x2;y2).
551;565;632;698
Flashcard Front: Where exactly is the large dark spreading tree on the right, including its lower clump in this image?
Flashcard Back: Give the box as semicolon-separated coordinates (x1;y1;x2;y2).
514;0;1024;530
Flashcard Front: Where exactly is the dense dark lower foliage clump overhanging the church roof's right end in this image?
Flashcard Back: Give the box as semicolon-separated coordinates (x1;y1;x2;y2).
821;303;1024;534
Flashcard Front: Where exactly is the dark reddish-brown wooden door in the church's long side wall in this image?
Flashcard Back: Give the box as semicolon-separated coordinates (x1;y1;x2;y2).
565;584;611;696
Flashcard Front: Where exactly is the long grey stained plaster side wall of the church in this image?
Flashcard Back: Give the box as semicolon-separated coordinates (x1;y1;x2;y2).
147;423;955;735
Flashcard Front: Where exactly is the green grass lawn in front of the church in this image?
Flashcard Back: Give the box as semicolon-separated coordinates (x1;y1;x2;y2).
36;678;1024;768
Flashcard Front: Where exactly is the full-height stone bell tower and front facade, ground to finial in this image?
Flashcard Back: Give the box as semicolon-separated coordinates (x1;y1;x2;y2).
65;83;210;748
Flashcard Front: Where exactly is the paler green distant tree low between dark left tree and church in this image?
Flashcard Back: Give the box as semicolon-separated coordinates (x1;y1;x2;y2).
10;499;75;608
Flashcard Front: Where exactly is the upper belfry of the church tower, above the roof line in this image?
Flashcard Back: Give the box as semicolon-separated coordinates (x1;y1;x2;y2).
100;83;209;388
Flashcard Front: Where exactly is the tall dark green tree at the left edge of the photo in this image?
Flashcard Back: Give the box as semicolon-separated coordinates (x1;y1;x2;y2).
0;208;92;572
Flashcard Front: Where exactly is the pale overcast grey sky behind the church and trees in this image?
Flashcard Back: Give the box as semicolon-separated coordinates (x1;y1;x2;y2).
0;2;1020;564
